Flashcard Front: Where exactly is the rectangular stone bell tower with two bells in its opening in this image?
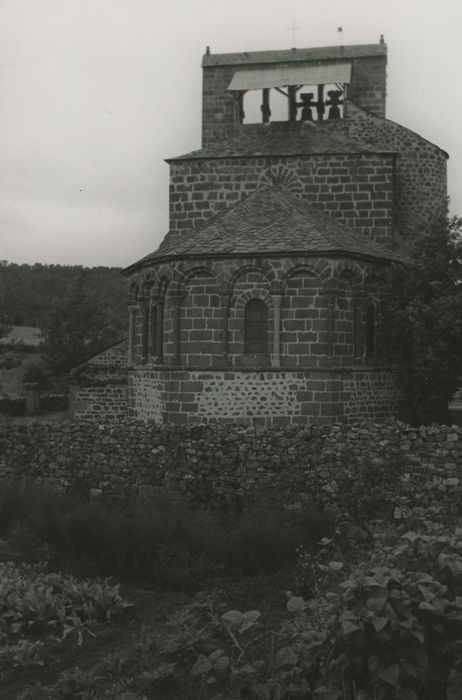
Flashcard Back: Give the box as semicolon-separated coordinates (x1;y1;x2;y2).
202;37;387;147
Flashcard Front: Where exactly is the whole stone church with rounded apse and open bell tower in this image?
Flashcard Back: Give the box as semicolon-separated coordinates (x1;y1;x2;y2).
70;38;447;425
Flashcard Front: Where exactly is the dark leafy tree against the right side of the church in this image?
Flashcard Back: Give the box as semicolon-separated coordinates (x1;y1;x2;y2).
391;212;462;423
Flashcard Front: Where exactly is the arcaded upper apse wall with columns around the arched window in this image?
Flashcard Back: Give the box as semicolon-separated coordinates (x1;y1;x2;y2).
128;256;387;369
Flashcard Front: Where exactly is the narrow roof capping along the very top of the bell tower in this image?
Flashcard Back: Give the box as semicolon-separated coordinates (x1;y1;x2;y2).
202;43;387;67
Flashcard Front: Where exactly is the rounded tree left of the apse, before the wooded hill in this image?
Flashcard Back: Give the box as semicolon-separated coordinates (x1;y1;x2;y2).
42;277;120;372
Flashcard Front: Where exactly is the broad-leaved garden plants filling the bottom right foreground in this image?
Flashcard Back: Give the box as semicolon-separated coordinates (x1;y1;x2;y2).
140;523;462;700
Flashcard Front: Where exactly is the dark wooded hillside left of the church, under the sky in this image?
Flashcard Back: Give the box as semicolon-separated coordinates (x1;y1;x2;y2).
0;261;127;380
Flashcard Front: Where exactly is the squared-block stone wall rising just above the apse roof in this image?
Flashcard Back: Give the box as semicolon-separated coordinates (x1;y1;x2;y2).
169;154;394;246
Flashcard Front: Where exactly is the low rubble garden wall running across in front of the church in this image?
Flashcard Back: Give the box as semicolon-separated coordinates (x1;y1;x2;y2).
0;420;462;508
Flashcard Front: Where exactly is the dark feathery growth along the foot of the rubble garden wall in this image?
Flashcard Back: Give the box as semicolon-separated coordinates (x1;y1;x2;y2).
0;484;330;587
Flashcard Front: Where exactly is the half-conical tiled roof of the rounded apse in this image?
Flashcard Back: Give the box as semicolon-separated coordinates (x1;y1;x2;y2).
127;186;406;271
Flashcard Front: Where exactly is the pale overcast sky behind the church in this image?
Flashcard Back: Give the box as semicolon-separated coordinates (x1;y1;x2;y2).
0;0;462;267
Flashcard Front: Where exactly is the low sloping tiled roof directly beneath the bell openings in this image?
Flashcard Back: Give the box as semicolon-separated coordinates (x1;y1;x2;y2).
167;122;392;162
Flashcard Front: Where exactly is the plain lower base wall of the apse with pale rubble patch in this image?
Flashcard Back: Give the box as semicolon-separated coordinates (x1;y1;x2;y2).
129;367;401;426
